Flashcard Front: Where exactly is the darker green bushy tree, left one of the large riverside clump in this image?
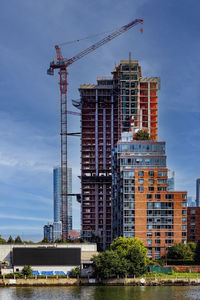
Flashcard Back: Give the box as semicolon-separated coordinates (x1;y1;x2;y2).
92;250;128;278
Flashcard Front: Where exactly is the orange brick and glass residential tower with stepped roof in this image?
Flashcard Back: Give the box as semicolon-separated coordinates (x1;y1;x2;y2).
112;132;187;259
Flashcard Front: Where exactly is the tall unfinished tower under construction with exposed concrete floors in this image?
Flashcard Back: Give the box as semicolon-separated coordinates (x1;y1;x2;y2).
76;59;159;250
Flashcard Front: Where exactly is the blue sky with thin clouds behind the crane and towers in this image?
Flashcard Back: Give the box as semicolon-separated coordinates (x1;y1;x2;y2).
0;0;200;240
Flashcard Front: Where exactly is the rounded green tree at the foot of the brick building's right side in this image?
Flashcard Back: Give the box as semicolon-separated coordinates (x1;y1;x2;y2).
167;243;193;260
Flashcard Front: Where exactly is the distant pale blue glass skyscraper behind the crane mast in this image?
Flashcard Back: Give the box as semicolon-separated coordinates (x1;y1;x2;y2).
53;167;72;238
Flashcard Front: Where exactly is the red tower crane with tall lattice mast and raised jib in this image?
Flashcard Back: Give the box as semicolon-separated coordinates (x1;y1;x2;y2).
47;19;143;239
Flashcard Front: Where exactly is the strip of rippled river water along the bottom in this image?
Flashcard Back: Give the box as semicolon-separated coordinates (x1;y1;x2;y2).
0;286;200;300
